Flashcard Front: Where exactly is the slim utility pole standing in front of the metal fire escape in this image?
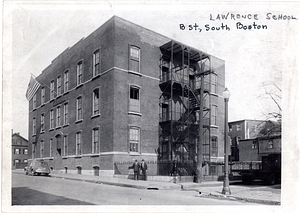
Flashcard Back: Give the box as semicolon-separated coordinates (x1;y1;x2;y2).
197;71;204;183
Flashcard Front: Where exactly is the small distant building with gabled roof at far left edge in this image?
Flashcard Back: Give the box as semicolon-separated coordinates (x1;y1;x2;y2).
11;132;28;169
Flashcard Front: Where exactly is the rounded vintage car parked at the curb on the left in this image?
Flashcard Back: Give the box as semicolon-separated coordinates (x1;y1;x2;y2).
24;159;50;175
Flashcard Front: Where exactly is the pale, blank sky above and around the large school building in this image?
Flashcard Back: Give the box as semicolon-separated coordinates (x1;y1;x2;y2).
4;1;300;138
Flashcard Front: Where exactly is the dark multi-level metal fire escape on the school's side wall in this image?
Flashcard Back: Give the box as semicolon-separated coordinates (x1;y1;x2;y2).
158;41;212;175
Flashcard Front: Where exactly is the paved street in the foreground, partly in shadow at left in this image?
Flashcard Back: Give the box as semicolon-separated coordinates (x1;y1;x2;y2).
12;173;251;205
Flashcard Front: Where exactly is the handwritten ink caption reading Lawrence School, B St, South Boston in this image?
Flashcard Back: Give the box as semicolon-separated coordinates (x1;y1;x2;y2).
179;13;298;32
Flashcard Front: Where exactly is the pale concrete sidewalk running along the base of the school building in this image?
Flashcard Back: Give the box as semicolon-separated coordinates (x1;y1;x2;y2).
13;170;281;205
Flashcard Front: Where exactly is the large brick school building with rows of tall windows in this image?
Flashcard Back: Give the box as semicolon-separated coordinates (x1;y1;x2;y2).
29;16;225;175
